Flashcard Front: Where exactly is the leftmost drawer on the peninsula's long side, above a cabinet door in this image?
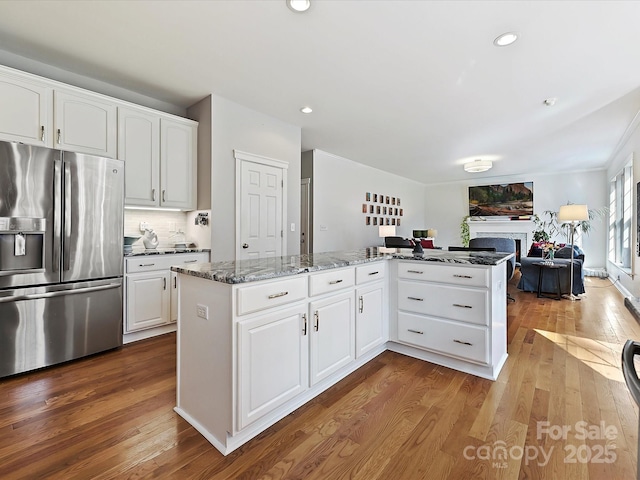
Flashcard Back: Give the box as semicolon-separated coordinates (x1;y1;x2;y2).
236;277;307;315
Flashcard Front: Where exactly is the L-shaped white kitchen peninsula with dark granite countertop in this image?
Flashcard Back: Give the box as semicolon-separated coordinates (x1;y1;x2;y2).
172;247;513;455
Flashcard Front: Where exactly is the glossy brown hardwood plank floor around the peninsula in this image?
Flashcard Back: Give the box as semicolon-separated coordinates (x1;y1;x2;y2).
0;278;640;480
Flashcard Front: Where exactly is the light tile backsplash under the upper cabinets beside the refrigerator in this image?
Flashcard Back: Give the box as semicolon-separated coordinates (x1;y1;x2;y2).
124;209;211;248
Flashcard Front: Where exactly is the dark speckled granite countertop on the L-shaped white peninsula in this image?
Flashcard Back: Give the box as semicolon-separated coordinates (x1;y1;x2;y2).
171;247;515;284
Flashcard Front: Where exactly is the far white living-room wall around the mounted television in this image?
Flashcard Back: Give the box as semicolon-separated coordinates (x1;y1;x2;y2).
425;170;608;267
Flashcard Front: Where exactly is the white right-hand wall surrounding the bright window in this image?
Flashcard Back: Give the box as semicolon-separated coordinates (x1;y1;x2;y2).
606;116;640;298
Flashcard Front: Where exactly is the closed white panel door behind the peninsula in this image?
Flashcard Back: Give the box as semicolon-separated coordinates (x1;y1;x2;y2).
236;161;284;260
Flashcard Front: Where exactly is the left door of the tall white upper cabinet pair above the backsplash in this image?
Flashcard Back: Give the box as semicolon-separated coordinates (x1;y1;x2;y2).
118;107;160;207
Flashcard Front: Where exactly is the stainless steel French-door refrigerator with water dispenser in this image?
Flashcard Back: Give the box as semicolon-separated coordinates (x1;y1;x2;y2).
0;142;124;377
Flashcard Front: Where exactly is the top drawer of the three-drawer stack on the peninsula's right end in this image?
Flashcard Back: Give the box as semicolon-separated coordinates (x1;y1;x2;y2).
398;262;489;287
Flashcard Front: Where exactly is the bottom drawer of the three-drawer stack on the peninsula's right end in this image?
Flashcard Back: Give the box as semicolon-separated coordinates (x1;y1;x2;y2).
398;312;489;364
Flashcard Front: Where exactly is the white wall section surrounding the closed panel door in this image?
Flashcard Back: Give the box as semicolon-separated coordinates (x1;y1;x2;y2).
211;95;302;261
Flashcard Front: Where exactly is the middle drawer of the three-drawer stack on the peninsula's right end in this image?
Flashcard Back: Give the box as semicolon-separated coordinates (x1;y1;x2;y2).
398;280;489;325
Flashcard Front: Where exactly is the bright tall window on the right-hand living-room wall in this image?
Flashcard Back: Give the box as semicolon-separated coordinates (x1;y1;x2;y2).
609;155;633;272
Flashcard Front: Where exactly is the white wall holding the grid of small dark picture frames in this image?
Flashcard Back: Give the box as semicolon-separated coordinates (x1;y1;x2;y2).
313;150;433;252
